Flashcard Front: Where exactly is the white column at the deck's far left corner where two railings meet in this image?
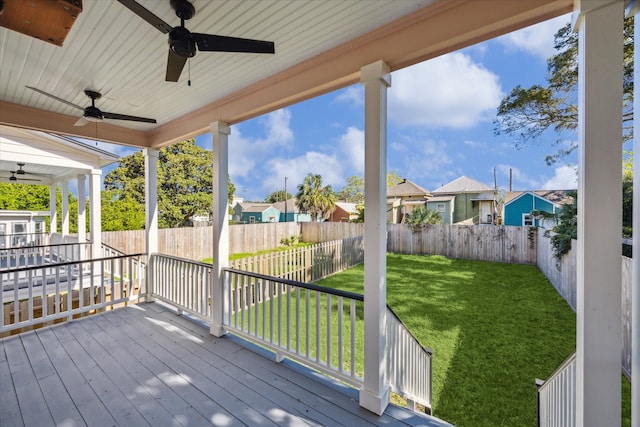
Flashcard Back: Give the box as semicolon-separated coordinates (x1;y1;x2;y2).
143;148;158;301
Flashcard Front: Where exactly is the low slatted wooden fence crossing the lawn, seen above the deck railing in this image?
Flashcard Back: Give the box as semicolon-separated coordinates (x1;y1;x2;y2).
229;237;364;282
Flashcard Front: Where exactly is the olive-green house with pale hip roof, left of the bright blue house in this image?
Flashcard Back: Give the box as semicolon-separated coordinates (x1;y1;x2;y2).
431;176;495;224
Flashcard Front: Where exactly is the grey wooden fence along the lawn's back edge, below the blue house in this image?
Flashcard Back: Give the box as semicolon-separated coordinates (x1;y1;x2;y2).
387;224;537;264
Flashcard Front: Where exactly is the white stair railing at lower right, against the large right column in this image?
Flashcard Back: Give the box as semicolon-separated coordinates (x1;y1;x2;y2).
536;353;576;427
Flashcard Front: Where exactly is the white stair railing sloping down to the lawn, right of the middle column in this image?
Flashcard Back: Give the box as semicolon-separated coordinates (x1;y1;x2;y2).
385;306;433;414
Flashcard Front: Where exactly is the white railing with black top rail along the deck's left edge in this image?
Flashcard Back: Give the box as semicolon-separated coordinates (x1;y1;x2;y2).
0;254;145;333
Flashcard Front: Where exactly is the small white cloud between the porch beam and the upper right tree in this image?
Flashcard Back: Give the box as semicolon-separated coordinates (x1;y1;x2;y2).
497;15;571;60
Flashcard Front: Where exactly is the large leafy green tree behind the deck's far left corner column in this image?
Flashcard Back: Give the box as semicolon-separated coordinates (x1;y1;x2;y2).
103;139;235;228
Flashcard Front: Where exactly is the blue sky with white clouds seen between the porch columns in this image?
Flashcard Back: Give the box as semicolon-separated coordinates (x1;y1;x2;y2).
97;15;577;200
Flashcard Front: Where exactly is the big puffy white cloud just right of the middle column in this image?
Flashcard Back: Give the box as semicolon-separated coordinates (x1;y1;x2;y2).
389;52;503;129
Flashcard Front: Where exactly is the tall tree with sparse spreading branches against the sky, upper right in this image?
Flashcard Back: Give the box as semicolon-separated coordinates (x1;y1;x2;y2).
494;17;633;164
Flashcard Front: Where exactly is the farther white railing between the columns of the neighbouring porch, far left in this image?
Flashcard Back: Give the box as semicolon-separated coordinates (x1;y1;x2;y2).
0;243;91;270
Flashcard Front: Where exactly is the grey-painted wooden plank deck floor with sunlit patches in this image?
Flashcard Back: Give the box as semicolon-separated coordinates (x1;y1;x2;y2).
0;303;449;427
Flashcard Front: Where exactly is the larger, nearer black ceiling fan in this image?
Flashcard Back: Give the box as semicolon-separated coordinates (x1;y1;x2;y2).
118;0;275;82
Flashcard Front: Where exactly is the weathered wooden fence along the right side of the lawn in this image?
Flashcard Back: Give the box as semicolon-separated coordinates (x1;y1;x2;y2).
538;229;633;378
